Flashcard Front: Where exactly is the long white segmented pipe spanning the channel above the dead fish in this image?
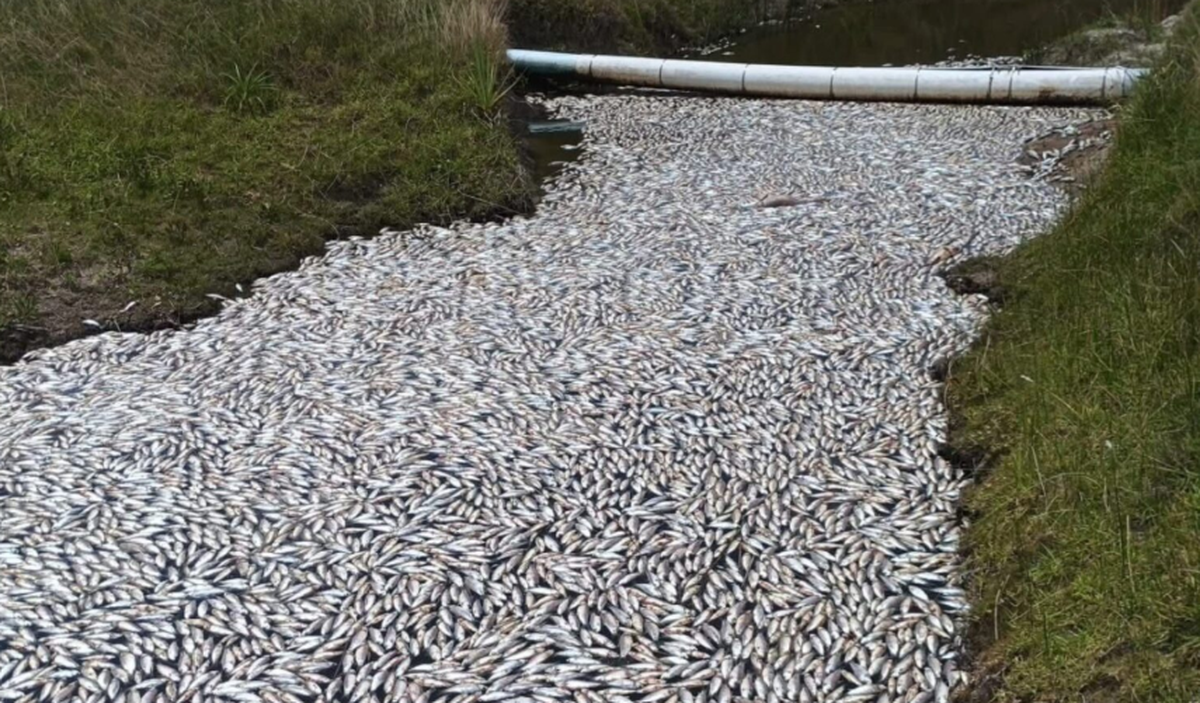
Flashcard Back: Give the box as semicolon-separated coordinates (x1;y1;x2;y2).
509;49;1145;104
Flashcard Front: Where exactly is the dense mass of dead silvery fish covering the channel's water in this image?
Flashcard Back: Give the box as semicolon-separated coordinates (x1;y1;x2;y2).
0;96;1093;703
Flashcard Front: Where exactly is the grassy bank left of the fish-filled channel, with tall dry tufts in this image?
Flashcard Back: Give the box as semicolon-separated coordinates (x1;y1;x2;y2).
0;0;530;352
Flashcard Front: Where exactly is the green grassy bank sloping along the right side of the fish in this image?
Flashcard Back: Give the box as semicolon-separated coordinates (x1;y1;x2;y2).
949;8;1200;702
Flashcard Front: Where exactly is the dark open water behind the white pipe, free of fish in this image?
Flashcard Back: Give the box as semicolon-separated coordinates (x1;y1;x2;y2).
704;0;1183;66
